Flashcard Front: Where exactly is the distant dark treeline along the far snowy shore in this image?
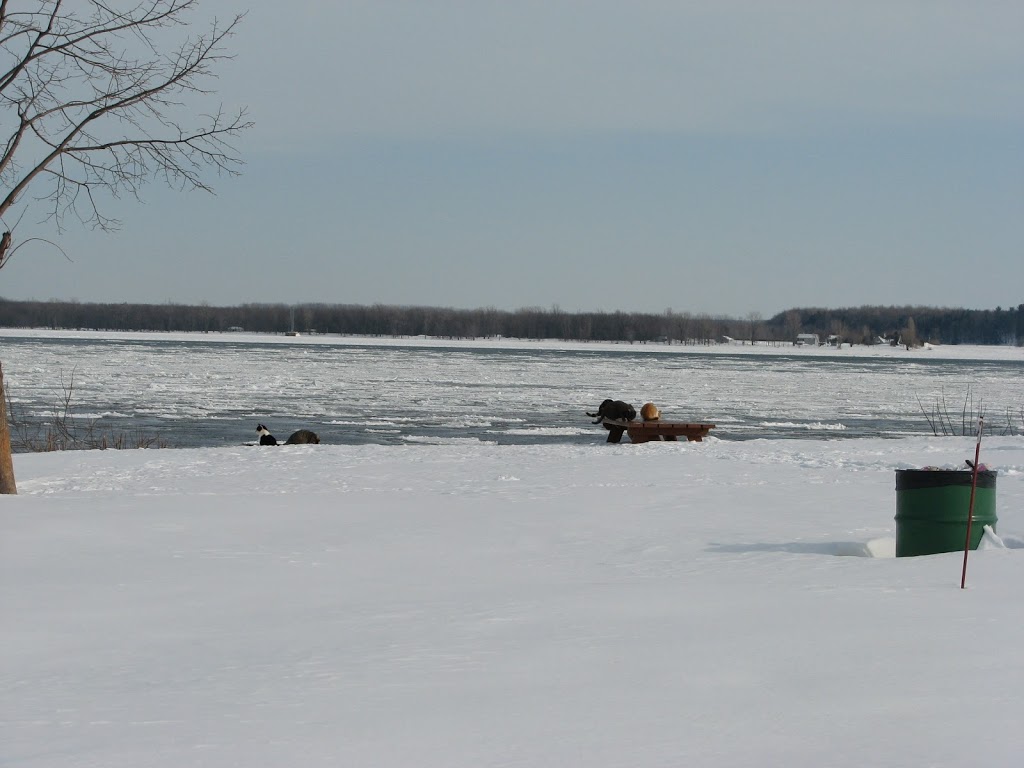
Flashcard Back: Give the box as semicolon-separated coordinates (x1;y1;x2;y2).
0;299;1024;345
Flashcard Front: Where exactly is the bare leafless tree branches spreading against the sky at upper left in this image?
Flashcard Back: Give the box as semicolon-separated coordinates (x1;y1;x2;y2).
0;0;252;240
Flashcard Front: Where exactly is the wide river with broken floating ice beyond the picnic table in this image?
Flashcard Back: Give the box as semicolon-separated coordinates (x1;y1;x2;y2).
0;331;1024;447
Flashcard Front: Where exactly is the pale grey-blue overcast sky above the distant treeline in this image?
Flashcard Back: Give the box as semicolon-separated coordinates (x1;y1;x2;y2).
0;0;1024;316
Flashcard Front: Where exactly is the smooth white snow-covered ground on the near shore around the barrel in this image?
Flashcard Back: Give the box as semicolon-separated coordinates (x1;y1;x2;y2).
0;436;1024;768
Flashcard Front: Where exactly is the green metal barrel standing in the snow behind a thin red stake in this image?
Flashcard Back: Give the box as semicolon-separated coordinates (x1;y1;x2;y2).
896;469;996;557
